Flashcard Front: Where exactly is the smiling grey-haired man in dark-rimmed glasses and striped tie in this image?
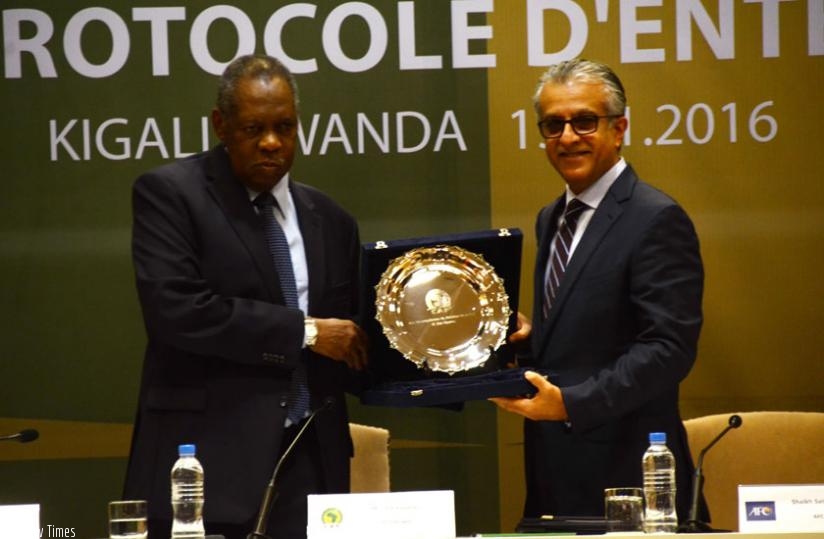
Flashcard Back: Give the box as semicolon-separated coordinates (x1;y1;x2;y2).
492;60;707;521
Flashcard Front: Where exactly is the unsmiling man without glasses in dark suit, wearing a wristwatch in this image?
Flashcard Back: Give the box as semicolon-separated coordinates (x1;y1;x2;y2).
125;56;366;539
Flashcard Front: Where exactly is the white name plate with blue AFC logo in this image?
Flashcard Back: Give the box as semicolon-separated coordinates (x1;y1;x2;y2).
738;485;824;532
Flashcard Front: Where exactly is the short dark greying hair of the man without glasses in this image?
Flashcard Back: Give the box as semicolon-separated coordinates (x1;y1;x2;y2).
216;54;298;118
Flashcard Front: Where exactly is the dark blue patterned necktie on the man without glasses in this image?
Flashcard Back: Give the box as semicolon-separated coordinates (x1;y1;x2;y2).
255;191;309;424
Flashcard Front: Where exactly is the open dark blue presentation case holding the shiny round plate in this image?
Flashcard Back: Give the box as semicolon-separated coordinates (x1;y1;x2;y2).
360;228;535;407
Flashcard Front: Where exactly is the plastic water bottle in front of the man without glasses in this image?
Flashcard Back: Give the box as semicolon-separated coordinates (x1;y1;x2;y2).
172;444;206;539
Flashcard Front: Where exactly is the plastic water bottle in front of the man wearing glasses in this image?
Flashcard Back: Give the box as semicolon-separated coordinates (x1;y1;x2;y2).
641;432;678;533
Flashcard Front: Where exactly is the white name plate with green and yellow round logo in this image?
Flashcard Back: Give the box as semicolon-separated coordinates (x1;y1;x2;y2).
306;490;455;539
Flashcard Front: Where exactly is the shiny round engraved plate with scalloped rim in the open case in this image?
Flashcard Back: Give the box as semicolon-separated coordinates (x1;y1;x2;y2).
375;245;512;374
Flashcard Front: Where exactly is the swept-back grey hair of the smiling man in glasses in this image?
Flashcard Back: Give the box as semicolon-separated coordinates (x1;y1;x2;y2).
532;58;627;115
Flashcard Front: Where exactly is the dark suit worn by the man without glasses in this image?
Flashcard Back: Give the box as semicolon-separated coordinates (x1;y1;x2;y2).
125;146;360;522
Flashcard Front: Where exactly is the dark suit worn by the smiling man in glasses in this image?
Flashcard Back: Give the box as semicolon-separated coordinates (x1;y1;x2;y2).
524;166;703;519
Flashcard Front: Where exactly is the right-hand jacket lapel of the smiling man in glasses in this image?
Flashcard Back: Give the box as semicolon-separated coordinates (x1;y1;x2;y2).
539;165;638;353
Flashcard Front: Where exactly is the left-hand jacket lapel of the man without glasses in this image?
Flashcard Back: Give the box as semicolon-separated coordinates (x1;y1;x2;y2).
206;146;283;303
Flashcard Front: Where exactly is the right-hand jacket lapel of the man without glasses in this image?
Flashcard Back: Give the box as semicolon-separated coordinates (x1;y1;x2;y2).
290;181;326;314
